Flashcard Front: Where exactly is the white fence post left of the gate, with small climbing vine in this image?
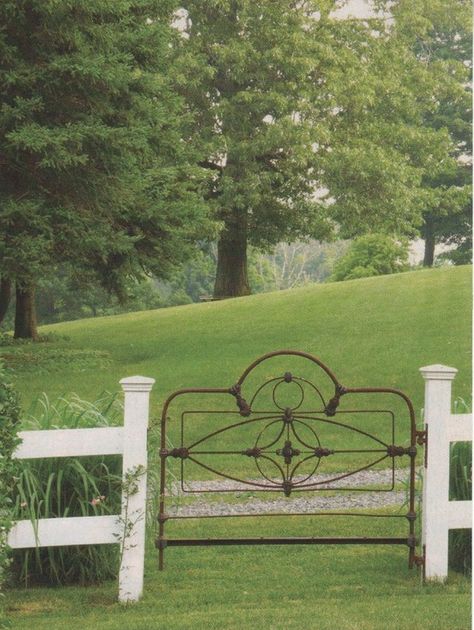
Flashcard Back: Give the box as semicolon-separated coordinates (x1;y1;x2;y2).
119;376;155;602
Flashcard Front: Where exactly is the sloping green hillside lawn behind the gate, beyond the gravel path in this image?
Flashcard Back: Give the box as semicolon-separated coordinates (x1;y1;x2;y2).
3;266;471;478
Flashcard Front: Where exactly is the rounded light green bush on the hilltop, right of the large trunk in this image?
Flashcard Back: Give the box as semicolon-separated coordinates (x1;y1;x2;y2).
331;234;409;281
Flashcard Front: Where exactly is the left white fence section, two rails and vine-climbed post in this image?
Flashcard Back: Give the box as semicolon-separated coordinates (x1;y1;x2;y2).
8;376;155;602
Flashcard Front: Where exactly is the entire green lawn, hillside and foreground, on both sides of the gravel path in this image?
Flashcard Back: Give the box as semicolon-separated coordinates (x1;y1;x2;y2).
2;266;471;630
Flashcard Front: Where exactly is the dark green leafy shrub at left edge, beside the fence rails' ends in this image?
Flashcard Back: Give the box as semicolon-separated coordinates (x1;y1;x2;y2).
0;360;20;625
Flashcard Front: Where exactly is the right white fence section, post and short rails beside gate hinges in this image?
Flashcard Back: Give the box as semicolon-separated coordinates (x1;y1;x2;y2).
420;365;472;580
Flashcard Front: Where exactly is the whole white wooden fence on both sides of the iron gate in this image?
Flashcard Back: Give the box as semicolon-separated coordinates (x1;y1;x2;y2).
8;365;472;602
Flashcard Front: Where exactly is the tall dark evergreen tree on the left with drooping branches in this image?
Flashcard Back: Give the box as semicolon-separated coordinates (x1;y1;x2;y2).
0;0;208;338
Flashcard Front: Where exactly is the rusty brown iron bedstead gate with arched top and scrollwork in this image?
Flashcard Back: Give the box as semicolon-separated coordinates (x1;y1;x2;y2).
156;350;423;569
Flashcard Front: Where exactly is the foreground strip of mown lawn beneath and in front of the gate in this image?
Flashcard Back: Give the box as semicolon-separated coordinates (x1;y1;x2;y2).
7;517;470;630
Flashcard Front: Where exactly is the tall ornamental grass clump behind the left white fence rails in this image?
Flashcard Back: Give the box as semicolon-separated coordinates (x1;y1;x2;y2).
12;394;123;586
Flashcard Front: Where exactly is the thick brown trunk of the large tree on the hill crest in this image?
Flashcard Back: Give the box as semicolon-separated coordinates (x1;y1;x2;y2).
214;214;250;298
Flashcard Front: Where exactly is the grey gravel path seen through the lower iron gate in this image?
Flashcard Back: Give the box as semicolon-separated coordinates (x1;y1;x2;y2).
167;469;409;516
